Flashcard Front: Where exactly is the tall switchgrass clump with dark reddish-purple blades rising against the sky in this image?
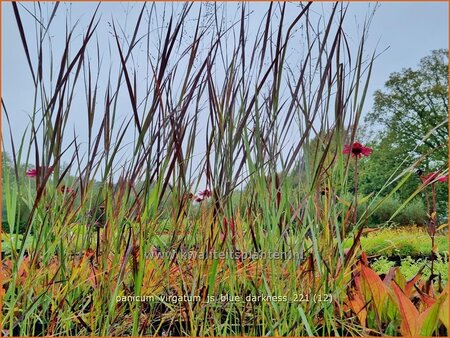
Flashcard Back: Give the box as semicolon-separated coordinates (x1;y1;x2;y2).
2;2;446;336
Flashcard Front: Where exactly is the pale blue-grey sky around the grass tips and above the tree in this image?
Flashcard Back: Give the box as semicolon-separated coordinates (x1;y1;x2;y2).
1;1;448;181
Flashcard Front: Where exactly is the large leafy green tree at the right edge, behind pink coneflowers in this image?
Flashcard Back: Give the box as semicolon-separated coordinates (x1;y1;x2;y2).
360;49;448;218
